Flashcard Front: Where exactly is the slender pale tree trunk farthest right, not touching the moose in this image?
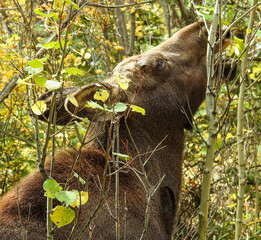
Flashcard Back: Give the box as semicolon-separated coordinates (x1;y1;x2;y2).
235;0;257;240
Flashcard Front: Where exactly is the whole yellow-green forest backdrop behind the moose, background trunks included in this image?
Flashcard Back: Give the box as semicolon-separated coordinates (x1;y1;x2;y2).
0;0;261;239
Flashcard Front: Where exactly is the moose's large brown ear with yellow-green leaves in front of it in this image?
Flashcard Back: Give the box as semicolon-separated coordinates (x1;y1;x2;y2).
39;83;119;125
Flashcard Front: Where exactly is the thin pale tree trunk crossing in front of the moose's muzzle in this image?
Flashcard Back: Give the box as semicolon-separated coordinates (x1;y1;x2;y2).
198;0;221;240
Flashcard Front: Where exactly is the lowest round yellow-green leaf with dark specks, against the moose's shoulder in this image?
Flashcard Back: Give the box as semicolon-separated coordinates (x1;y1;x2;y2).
50;206;75;228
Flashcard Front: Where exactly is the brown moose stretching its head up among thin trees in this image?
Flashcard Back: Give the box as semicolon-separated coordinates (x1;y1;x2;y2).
0;22;229;240
